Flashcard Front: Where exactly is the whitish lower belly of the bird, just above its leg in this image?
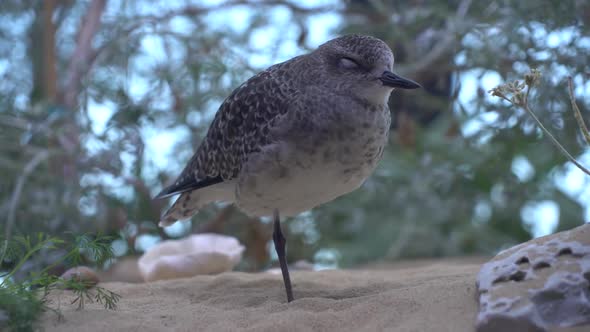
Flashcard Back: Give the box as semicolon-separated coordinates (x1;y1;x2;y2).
236;139;380;216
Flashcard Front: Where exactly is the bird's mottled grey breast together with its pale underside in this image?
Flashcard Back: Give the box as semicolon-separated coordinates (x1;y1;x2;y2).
236;104;390;216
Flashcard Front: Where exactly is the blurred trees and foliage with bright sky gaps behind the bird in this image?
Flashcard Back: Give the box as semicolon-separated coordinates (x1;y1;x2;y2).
0;0;590;271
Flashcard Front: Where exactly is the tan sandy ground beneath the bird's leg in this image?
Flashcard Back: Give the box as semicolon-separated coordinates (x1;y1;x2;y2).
41;259;484;332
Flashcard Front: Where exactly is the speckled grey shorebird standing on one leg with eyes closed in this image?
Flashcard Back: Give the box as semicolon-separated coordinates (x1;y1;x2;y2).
155;34;421;302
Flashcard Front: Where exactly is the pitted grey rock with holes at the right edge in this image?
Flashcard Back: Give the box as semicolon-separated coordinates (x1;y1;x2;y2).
477;224;590;332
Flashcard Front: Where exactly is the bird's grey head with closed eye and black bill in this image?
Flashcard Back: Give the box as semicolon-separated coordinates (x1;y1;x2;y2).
314;35;420;104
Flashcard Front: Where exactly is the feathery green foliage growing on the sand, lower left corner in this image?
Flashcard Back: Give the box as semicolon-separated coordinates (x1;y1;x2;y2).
0;233;120;331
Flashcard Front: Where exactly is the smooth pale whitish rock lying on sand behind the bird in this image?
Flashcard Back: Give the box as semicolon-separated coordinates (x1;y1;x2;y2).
137;234;244;281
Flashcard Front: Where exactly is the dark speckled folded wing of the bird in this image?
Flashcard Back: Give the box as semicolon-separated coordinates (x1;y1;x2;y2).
155;62;298;198
